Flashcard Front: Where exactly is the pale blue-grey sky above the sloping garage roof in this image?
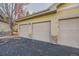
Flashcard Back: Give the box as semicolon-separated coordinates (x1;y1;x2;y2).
24;3;52;13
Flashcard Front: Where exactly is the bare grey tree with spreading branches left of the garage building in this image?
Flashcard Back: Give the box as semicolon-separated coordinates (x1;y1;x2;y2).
0;3;16;34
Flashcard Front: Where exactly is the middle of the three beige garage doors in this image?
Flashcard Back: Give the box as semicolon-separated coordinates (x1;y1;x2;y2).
33;22;50;42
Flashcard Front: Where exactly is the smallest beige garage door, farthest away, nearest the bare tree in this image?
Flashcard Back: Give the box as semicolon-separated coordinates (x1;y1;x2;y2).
19;25;29;38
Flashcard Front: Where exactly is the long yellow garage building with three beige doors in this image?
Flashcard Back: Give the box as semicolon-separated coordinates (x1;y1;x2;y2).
16;3;79;48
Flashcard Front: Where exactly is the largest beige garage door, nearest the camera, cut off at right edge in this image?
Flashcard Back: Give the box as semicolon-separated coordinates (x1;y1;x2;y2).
58;18;79;48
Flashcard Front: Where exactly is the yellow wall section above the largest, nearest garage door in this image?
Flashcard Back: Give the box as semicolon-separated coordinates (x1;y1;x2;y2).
57;4;79;19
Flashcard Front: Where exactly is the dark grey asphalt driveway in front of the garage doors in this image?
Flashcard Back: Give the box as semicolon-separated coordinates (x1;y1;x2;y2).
0;37;79;56
